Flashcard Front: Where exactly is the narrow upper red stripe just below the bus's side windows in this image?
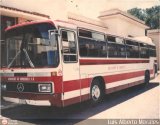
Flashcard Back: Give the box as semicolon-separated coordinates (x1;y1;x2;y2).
80;59;149;65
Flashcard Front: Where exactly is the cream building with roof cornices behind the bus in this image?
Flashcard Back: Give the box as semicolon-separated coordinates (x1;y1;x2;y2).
0;2;160;67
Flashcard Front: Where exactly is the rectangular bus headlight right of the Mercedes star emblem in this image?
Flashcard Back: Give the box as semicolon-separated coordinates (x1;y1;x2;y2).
38;83;52;93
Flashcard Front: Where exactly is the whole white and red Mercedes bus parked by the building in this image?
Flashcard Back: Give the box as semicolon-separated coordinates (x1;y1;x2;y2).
1;20;157;107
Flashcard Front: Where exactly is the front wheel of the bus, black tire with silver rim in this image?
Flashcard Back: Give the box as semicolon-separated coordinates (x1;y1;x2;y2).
90;79;104;104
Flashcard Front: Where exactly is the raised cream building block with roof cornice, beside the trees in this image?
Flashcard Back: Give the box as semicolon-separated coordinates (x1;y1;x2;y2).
98;8;149;37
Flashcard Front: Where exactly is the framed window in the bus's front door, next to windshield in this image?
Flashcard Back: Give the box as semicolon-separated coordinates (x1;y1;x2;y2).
61;30;77;62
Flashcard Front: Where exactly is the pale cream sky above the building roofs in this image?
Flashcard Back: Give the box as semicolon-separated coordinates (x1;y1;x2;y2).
1;0;160;18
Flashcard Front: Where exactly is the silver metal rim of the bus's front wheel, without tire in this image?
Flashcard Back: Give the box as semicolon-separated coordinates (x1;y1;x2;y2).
92;85;100;101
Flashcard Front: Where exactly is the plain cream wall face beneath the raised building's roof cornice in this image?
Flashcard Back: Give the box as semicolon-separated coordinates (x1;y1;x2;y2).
100;15;148;36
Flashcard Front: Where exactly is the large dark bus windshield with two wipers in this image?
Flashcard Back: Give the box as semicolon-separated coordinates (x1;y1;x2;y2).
4;23;59;68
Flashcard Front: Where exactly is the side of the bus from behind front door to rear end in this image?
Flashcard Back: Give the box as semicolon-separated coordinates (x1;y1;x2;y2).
78;28;157;102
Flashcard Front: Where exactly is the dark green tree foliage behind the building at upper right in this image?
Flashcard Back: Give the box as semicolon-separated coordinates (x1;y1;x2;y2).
127;6;160;29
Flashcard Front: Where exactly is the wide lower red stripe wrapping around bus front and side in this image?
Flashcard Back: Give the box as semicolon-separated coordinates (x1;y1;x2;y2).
2;70;153;93
